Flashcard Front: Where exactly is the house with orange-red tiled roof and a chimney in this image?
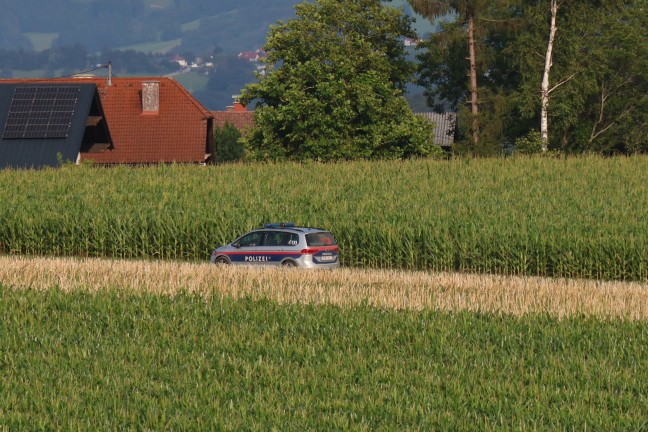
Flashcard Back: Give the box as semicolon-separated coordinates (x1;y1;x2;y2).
0;77;214;164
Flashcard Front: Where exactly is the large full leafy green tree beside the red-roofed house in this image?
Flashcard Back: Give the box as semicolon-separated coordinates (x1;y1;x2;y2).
242;0;440;160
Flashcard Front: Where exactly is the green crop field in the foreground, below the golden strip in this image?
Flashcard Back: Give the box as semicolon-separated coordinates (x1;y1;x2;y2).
0;286;648;431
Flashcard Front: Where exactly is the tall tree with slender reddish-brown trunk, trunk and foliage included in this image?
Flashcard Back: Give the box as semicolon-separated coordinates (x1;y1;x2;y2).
408;0;517;154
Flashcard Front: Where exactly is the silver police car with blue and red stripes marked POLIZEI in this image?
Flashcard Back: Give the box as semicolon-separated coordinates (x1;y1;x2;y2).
210;223;340;269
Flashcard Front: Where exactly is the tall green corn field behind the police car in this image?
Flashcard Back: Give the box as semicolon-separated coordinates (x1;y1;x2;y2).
0;157;648;281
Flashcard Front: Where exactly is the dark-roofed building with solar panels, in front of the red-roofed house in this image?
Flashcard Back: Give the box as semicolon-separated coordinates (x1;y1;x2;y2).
0;80;114;168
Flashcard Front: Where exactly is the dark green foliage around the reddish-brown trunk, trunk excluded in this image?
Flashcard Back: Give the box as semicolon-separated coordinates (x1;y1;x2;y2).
411;0;526;156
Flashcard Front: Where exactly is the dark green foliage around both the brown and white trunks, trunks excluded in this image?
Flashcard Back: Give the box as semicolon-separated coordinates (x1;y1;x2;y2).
410;0;648;154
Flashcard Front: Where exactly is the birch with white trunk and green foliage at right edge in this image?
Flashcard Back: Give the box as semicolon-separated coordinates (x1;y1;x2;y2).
510;0;648;154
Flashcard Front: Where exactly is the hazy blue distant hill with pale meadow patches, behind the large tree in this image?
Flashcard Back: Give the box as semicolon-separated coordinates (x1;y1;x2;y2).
0;0;432;53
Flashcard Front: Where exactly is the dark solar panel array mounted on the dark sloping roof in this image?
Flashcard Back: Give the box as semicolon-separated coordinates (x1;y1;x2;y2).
2;86;80;139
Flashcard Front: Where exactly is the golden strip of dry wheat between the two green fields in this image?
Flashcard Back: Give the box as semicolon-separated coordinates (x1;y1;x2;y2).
0;256;648;320
